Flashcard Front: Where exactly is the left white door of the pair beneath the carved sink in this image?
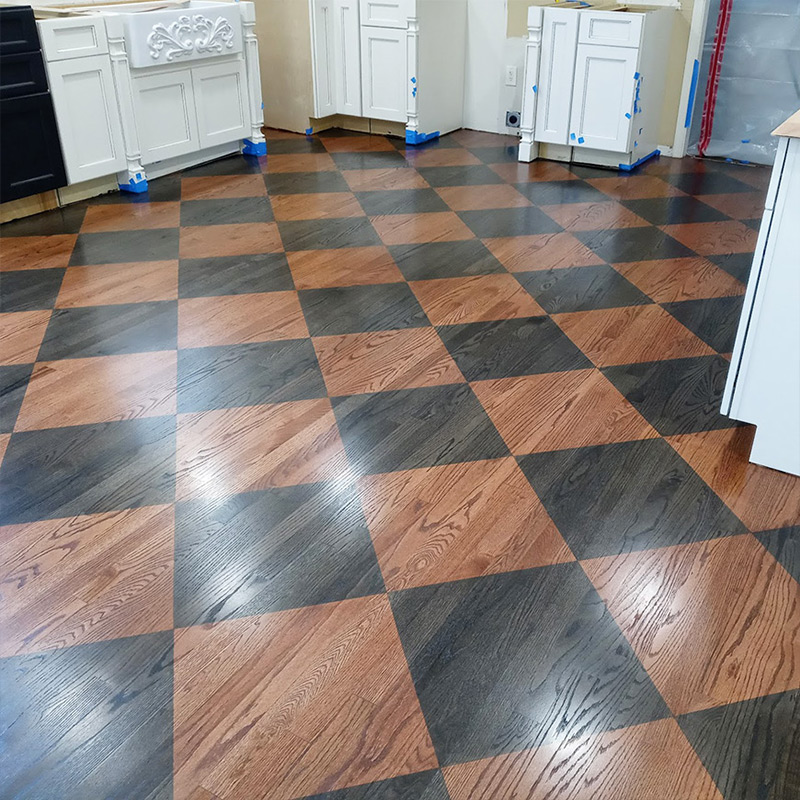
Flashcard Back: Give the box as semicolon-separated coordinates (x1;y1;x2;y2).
133;69;199;164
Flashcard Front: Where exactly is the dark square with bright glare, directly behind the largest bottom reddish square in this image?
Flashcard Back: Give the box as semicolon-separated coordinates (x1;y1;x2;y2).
175;483;383;627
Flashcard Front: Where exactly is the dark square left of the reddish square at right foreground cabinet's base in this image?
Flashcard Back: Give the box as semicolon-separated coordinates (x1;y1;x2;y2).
519;439;745;558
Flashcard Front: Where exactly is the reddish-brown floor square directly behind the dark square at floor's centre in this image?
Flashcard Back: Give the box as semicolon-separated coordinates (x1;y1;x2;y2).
314;328;464;396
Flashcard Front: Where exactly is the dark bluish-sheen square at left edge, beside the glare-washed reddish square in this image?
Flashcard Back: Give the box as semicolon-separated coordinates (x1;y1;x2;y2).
0;417;175;525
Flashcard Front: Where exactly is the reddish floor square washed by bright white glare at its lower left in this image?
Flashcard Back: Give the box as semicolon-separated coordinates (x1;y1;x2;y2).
177;399;347;500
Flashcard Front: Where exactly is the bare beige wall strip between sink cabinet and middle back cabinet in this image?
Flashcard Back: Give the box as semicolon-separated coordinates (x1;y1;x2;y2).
254;0;314;133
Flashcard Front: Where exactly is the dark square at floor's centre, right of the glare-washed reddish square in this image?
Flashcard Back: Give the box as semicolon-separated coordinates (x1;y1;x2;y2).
333;384;508;475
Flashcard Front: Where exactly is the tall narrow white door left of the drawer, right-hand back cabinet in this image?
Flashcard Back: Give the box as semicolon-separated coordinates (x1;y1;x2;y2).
536;8;581;144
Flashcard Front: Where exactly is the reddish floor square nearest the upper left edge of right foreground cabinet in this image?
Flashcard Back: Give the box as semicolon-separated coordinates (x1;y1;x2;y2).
612;256;745;303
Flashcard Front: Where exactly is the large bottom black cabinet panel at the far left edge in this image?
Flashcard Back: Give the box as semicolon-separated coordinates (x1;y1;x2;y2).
0;92;67;202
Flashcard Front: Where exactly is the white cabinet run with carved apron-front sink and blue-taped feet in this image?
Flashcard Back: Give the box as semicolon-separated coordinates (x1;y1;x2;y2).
37;0;266;192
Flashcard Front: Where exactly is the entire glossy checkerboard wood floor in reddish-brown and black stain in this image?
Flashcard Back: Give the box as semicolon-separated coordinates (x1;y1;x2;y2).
0;131;800;800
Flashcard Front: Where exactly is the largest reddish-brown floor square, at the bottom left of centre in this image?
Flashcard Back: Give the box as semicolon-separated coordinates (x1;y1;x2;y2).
175;596;437;800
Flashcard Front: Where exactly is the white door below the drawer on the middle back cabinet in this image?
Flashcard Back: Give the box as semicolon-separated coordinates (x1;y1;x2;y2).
361;25;407;122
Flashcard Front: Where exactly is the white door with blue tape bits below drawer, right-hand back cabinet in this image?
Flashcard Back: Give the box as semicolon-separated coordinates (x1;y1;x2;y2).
570;44;639;153
